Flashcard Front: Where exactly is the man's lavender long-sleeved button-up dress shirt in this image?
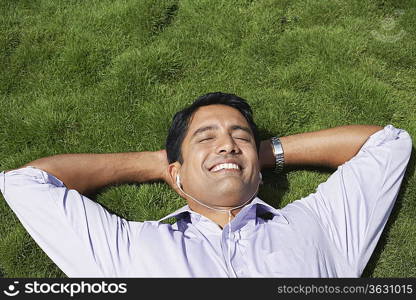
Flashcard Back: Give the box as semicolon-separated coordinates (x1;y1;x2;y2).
0;125;412;277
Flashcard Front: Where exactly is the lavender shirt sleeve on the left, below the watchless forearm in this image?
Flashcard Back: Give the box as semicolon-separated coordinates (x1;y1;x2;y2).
0;167;142;277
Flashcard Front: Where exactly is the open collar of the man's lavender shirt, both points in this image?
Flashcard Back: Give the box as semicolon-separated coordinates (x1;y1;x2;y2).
158;197;289;224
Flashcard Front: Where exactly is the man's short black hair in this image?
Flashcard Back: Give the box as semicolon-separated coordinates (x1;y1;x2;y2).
165;92;260;164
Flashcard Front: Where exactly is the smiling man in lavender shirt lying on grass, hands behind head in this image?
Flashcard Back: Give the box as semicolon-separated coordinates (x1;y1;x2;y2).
0;93;412;277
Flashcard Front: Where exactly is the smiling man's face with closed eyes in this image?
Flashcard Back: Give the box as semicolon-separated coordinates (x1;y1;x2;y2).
172;105;260;207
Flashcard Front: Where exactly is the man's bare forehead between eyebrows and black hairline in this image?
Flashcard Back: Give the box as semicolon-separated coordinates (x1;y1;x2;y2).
188;104;248;133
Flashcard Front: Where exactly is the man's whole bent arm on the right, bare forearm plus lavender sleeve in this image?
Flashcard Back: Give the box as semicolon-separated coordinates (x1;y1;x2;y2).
270;125;412;276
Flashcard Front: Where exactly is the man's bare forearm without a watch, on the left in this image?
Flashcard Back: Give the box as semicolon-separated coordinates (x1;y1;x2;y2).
6;150;168;195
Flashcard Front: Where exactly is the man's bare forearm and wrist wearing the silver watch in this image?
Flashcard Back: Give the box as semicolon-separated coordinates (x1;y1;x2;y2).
260;125;383;169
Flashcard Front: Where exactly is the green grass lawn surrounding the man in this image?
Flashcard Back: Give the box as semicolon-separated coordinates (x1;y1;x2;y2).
0;0;416;277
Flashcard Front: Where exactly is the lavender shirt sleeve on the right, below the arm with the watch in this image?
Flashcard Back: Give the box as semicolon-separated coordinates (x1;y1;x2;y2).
299;125;412;276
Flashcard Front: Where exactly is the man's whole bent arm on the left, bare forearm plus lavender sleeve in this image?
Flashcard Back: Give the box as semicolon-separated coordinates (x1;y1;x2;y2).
0;152;159;277
